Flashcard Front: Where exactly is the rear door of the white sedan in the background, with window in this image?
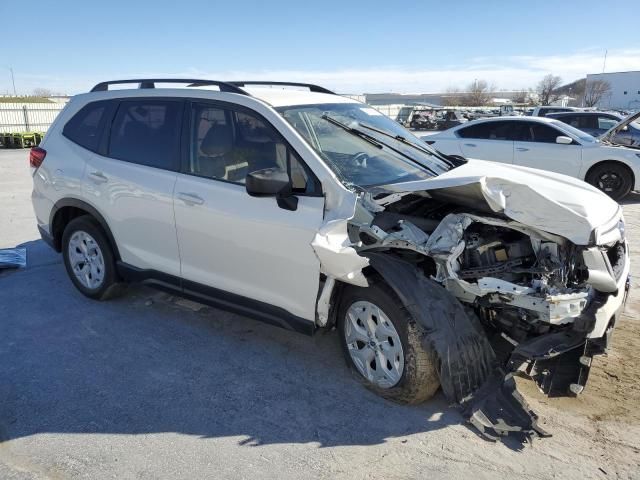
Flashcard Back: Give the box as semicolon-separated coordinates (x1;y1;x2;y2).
456;121;513;163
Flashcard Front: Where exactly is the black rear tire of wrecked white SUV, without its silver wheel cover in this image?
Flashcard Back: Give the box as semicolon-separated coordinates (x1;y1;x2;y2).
62;215;123;300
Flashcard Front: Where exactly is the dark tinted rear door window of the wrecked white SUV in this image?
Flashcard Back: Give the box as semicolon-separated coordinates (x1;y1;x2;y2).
108;99;183;170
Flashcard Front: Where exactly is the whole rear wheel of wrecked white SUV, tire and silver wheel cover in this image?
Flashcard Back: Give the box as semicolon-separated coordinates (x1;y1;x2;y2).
62;215;122;300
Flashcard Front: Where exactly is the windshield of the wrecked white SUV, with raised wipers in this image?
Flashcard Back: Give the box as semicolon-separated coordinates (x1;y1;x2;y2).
277;103;452;187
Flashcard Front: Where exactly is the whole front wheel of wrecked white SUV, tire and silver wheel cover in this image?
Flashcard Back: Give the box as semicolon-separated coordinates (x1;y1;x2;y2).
338;282;440;403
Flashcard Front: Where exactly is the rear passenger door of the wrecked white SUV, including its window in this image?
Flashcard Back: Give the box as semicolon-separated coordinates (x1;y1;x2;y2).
83;97;184;276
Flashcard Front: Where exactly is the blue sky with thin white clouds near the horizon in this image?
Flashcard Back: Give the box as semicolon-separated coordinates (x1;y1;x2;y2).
0;0;640;94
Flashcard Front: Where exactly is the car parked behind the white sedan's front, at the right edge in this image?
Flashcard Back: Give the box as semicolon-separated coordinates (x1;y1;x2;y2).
547;112;640;146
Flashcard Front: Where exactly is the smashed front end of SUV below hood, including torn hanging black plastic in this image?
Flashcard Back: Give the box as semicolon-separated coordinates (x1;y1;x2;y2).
316;188;628;439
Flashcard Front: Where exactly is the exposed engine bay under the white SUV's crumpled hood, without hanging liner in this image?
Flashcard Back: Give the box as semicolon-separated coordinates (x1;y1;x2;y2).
351;190;612;338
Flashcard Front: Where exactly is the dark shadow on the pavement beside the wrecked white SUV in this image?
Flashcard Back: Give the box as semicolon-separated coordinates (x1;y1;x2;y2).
0;240;484;449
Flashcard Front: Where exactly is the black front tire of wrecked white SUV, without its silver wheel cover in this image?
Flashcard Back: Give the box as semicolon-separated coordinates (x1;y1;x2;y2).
337;281;440;404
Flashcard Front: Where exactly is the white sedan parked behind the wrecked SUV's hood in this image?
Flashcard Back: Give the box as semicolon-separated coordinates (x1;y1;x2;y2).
424;117;640;200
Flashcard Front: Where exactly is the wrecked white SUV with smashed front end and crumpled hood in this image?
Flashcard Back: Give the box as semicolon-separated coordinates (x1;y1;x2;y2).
30;79;629;437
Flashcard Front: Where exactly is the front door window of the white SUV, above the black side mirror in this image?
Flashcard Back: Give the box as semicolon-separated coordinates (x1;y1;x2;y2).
188;104;313;193
